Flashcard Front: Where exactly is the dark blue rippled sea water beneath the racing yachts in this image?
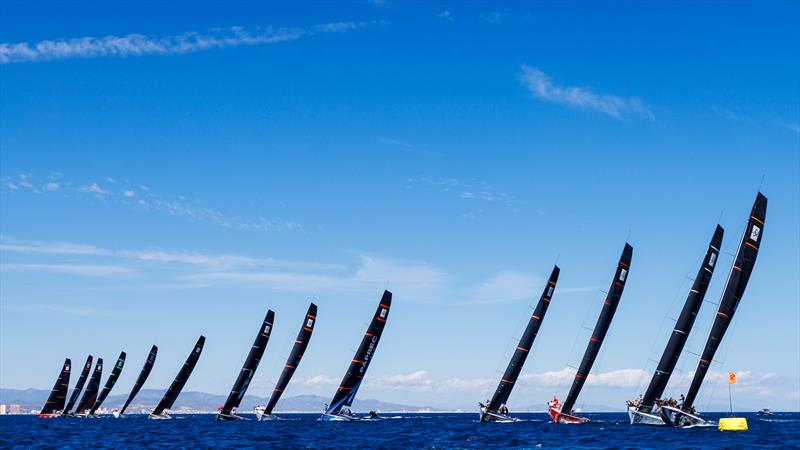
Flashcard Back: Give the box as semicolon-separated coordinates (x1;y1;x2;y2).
0;413;800;449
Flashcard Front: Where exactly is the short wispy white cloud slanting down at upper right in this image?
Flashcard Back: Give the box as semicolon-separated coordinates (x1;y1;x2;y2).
519;64;654;119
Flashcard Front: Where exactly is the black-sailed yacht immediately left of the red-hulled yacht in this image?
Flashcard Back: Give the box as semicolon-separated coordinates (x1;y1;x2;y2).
479;266;560;422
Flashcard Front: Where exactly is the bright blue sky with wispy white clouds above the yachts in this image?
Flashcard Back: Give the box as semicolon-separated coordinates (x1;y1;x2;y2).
0;0;800;410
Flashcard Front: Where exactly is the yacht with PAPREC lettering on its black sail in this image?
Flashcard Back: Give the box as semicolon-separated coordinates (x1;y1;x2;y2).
320;291;392;421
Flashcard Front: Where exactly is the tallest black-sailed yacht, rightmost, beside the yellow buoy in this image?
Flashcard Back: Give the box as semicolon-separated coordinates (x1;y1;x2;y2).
660;192;767;428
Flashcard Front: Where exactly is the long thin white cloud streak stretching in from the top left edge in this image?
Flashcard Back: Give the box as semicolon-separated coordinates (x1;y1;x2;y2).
0;21;384;64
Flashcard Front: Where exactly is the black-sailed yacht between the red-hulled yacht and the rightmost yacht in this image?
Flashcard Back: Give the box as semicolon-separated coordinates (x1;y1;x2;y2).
628;225;725;425
